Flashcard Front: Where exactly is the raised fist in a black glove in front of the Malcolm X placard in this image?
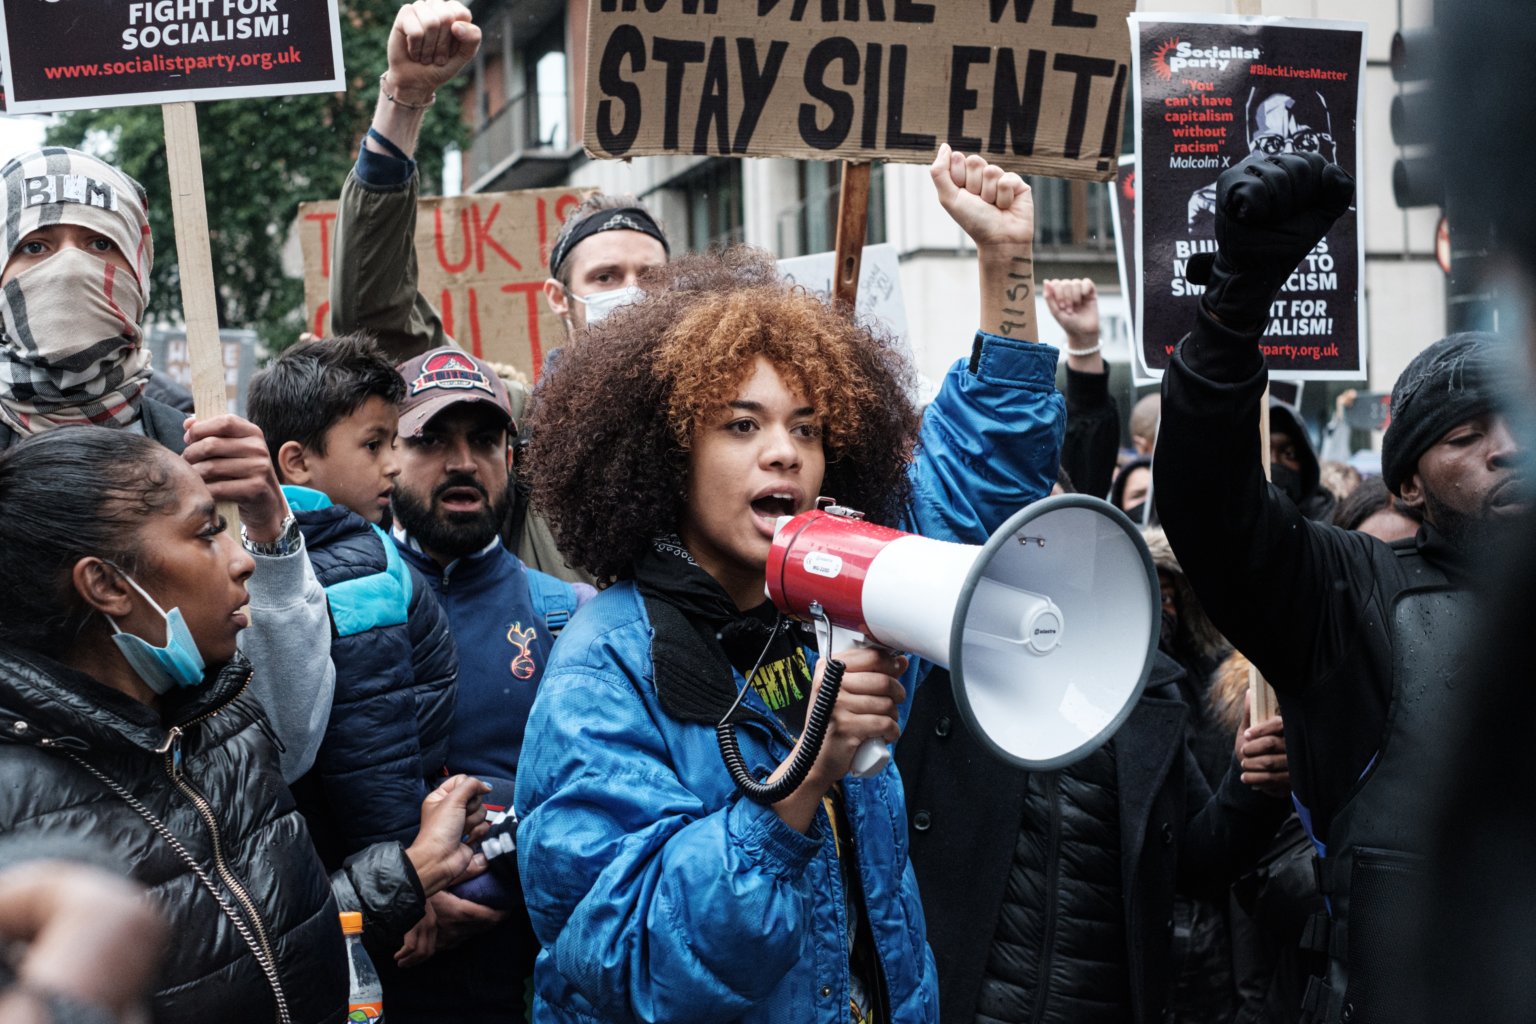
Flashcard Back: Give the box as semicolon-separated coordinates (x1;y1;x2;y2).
1189;154;1355;327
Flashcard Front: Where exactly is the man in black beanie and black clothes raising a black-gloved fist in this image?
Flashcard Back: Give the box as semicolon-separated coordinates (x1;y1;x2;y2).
1157;154;1530;1021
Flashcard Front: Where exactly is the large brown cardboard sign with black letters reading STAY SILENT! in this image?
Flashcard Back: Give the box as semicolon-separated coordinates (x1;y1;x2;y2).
585;0;1135;181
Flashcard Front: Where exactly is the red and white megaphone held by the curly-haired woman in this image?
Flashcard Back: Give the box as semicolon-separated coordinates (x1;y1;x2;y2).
768;494;1161;775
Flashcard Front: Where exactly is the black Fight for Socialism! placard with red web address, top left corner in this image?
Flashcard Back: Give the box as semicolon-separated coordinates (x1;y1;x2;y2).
0;0;346;114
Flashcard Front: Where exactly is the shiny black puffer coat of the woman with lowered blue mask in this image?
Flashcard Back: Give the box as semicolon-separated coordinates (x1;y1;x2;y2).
0;645;347;1024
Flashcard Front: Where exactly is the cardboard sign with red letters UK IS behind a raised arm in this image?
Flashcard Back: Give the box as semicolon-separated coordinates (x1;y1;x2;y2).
298;189;591;381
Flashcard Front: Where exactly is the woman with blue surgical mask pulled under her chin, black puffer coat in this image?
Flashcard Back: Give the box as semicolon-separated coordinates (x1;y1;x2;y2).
0;427;484;1024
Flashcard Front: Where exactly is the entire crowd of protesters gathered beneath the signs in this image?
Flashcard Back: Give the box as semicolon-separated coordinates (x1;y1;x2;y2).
0;0;1536;1024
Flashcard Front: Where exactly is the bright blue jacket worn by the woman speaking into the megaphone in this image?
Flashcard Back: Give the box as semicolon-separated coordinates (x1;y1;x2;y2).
516;335;1064;1024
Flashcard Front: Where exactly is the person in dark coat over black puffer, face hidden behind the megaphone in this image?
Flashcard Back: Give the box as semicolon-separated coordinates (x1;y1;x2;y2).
895;466;1289;1024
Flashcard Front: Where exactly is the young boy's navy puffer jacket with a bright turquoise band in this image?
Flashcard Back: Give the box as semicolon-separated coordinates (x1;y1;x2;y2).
283;487;459;870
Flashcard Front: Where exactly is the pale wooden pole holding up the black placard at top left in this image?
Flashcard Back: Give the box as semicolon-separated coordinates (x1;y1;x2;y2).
160;101;240;530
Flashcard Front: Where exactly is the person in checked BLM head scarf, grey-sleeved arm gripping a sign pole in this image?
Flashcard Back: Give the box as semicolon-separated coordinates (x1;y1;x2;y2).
0;146;335;781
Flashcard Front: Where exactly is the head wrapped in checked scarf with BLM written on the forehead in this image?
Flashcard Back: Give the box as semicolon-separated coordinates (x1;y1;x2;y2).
0;146;158;447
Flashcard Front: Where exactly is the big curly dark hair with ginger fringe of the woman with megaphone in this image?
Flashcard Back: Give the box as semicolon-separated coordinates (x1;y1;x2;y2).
528;246;919;580
